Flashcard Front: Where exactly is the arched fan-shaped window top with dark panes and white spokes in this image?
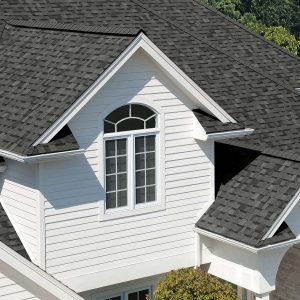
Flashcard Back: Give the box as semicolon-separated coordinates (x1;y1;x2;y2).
104;104;156;133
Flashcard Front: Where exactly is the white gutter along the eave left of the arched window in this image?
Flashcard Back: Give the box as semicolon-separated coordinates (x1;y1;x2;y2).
0;149;85;163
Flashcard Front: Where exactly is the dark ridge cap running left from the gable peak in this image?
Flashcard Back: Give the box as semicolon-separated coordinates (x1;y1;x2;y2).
5;19;142;36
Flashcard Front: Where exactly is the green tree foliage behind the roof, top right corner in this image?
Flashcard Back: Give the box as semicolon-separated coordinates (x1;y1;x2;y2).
203;0;300;54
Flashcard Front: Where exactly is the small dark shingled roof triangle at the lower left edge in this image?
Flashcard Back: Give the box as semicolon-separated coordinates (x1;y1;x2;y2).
0;199;29;259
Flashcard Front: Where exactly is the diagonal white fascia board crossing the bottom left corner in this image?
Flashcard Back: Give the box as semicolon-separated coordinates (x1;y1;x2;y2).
0;242;83;300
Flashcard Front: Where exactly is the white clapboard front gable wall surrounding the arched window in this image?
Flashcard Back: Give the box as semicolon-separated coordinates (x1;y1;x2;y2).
39;50;214;292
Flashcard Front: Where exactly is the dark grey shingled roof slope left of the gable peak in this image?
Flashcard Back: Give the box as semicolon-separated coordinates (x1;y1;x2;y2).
0;21;135;155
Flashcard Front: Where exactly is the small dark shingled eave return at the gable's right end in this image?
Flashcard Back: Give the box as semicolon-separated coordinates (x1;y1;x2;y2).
194;109;245;134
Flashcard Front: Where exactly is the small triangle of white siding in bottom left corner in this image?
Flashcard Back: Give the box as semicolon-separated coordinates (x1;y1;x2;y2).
0;273;38;300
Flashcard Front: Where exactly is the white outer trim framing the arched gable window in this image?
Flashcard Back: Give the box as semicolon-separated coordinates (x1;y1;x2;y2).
99;101;166;221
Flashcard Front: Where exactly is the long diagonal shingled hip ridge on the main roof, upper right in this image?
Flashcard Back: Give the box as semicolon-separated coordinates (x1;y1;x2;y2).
130;0;299;96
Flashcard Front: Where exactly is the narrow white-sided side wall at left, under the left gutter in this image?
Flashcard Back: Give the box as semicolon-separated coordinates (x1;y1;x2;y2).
0;159;39;263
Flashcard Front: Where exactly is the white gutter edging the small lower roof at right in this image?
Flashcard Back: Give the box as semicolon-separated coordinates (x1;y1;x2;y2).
193;227;300;254
